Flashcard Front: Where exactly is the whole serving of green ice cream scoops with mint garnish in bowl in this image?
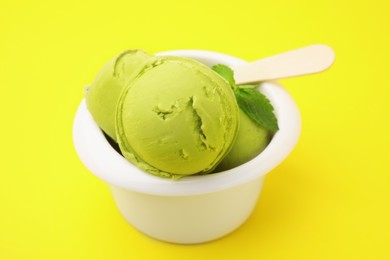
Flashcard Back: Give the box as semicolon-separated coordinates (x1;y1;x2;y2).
86;50;277;179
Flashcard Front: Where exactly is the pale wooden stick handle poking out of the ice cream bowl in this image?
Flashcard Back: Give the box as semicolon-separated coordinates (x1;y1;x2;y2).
234;44;335;84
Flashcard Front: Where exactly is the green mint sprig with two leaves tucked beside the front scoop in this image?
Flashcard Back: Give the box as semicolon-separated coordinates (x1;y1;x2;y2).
211;64;279;133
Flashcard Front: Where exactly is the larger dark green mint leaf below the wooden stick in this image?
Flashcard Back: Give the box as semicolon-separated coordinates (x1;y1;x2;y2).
234;88;279;133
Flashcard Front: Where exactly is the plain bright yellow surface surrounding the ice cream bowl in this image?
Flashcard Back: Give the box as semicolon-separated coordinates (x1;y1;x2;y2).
0;0;390;260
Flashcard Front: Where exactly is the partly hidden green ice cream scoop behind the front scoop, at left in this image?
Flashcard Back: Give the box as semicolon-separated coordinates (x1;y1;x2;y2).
85;50;157;140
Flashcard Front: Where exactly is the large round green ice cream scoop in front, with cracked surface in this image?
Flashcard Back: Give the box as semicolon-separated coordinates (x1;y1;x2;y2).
116;57;239;178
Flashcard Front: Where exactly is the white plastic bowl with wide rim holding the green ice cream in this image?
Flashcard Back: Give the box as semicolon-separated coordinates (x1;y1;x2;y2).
73;50;301;244
